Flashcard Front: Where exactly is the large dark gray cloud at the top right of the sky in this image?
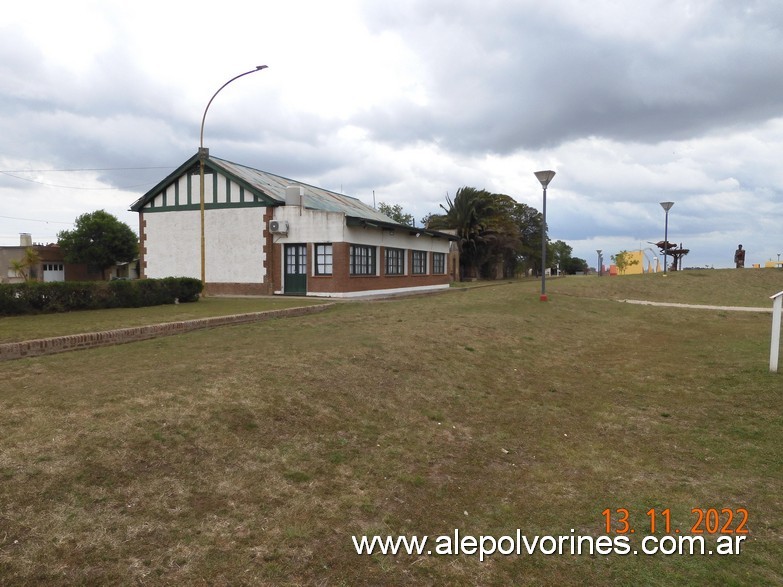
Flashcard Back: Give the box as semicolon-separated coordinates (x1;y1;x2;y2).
362;2;783;153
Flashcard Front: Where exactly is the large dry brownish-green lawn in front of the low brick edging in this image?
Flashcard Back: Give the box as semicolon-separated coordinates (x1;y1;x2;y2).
0;270;783;586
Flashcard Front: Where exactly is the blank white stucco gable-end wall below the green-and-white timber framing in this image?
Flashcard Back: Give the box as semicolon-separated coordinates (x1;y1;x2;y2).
144;207;266;283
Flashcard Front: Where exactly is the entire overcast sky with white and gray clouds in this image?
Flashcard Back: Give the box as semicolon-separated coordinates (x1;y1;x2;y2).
0;0;783;267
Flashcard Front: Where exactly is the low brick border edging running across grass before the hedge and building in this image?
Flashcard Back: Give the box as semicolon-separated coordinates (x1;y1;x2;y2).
0;303;334;361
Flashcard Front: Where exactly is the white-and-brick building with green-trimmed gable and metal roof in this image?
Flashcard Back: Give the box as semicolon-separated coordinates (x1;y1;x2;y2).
131;152;458;297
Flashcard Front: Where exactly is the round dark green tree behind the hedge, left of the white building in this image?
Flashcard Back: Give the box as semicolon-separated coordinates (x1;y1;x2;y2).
57;210;139;279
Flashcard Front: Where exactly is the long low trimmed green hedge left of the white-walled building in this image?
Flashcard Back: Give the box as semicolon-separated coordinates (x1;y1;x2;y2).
0;277;203;316
